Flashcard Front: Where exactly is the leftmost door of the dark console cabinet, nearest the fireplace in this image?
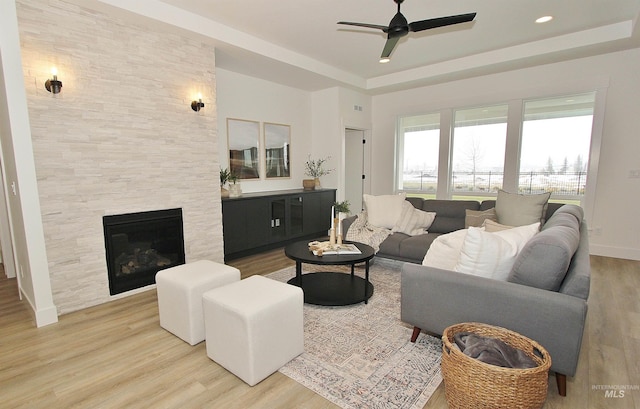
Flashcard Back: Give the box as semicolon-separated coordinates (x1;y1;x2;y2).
222;199;269;254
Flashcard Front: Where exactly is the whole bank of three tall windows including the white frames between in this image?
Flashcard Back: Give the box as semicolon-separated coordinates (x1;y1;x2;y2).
396;92;599;204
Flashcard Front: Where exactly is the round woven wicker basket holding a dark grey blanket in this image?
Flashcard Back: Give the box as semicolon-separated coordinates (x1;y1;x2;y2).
441;323;551;409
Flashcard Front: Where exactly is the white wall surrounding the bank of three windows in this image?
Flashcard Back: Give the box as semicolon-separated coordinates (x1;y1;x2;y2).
372;49;640;260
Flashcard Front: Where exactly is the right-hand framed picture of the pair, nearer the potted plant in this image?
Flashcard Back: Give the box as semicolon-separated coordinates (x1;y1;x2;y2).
264;122;291;178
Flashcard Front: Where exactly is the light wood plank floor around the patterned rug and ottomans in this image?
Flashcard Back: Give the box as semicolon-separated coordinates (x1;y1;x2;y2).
0;250;640;409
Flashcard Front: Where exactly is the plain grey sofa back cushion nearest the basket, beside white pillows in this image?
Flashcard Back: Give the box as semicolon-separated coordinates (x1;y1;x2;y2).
508;212;580;291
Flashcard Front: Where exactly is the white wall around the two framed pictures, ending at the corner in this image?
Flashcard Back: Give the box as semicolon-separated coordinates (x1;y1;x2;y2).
216;69;312;193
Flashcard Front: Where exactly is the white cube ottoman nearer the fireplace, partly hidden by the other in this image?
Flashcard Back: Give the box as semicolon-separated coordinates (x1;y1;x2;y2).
156;260;240;345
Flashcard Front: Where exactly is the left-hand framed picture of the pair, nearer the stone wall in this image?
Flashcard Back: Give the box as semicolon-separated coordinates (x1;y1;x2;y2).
227;118;260;179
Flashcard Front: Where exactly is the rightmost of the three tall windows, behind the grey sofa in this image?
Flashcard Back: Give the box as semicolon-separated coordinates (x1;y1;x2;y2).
518;92;595;199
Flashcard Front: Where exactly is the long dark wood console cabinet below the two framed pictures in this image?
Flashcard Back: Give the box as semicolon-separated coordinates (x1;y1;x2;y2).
222;189;336;260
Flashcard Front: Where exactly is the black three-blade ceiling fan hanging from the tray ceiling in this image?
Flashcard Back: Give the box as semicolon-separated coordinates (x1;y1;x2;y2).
338;0;476;62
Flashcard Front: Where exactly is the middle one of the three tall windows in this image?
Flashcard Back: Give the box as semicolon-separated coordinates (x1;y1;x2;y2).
451;105;508;196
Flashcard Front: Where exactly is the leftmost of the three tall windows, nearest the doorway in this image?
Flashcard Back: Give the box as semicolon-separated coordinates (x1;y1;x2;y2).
397;113;440;197
